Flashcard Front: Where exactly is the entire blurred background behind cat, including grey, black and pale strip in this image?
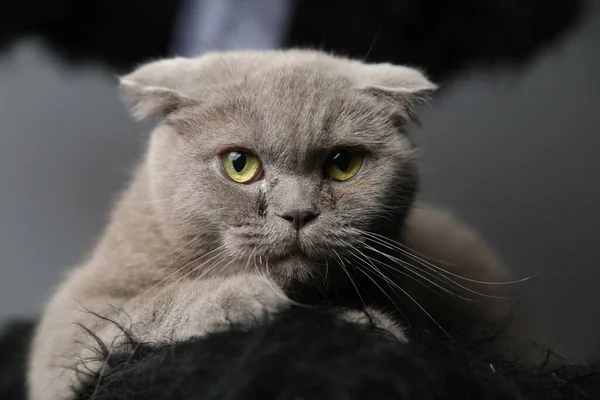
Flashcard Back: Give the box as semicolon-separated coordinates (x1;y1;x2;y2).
0;0;600;359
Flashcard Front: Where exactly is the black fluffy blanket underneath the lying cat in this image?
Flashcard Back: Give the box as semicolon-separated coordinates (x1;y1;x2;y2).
0;309;600;400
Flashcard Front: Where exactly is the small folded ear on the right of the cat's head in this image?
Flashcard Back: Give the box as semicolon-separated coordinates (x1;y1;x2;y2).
359;64;437;120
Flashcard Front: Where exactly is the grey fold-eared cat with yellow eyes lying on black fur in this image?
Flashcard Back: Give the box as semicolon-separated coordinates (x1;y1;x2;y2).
28;50;510;400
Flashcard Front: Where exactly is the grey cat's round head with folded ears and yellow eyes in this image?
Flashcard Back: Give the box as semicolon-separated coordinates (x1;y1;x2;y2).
121;50;435;282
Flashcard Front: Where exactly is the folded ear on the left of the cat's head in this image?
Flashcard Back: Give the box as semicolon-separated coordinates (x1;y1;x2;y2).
120;58;198;120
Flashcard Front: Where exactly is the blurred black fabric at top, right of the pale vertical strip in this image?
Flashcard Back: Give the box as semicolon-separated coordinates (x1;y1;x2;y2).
290;0;585;82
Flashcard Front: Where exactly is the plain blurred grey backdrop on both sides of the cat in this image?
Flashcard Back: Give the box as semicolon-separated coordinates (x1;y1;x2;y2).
0;6;600;357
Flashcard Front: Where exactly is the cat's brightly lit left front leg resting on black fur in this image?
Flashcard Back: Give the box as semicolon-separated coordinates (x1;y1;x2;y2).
28;275;290;400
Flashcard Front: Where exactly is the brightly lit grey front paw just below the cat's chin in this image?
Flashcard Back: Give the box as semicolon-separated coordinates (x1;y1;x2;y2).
189;275;290;335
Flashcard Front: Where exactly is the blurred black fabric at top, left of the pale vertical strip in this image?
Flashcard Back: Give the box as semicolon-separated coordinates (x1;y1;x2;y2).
0;0;178;70
